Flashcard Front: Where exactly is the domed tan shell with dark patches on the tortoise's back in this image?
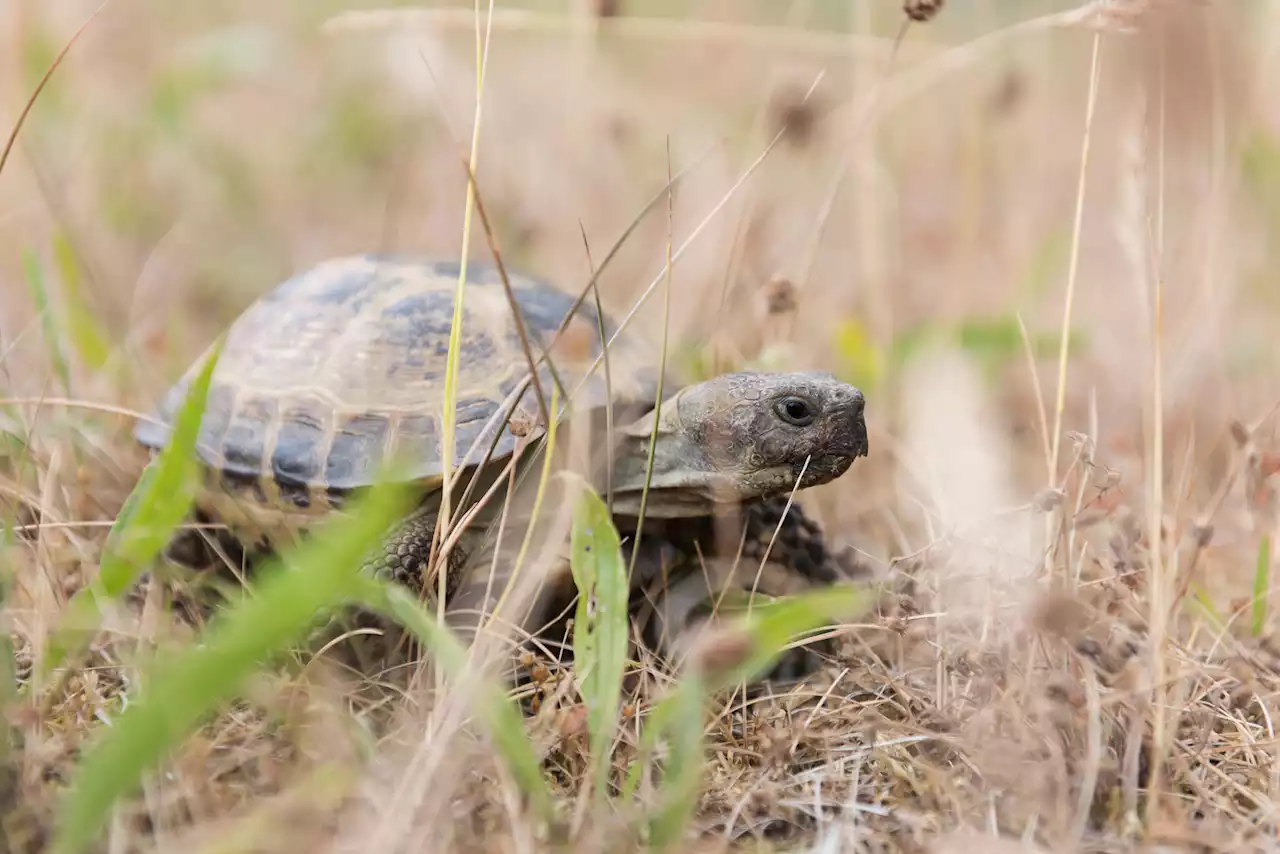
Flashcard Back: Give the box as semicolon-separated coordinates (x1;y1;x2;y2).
134;255;673;522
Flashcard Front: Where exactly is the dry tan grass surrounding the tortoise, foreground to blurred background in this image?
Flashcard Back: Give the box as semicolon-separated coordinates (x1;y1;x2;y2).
0;0;1280;853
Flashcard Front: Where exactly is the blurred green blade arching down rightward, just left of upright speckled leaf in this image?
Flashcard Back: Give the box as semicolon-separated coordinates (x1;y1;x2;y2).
360;579;552;819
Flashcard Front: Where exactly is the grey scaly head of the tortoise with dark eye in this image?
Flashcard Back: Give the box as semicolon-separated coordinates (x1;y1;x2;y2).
613;371;868;517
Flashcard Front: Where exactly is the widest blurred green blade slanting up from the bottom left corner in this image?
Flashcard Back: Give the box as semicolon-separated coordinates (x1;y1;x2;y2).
50;478;410;854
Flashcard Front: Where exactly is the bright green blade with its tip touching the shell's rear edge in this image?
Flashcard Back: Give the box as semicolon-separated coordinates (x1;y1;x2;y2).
42;339;223;675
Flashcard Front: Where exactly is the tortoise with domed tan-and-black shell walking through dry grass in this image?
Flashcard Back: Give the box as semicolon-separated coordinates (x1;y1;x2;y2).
134;254;868;655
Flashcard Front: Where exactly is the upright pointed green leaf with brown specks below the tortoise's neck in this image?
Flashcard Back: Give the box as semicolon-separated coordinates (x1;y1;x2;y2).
570;484;628;799
